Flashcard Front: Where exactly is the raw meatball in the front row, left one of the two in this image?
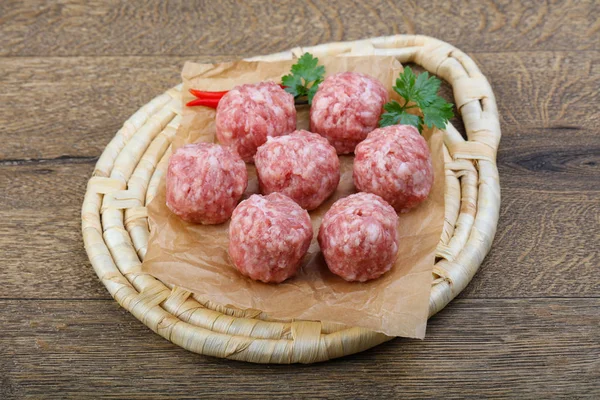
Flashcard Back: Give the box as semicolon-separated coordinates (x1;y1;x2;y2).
229;193;313;283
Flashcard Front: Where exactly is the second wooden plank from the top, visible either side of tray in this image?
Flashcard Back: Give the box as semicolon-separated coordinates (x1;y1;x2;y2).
0;52;600;161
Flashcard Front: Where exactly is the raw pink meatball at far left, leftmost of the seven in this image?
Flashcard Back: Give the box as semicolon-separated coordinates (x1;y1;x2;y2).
167;143;248;224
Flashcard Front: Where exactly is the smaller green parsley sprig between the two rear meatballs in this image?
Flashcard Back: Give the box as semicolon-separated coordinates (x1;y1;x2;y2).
281;53;325;104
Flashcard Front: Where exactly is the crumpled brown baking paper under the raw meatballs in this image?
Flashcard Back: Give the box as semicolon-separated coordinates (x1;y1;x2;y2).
143;57;444;338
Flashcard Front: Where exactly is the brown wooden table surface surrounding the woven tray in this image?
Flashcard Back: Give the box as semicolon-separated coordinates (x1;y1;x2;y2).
0;0;600;399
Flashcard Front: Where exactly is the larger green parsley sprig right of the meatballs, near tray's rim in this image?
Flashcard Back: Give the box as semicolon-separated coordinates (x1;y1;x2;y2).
379;67;454;132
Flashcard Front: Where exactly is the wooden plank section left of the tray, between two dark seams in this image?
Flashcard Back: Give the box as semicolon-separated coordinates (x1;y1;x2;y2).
0;163;111;299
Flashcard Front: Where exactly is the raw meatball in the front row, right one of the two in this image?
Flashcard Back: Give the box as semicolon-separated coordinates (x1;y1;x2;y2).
318;193;398;282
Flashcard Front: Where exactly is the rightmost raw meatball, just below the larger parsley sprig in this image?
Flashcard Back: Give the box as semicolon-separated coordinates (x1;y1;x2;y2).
353;125;433;212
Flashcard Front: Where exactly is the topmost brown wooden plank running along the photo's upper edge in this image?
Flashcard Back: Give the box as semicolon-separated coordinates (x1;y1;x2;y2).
0;0;600;57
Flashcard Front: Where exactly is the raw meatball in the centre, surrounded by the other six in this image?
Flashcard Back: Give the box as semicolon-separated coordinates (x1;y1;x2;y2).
254;130;340;210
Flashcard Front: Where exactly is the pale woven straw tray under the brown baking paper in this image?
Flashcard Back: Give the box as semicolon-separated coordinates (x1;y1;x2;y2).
82;35;500;363
